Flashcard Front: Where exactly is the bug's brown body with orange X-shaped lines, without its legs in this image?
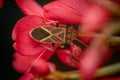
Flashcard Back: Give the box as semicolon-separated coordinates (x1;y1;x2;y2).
30;26;76;44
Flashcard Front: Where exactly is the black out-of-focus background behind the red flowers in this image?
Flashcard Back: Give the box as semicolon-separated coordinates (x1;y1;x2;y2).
0;0;120;80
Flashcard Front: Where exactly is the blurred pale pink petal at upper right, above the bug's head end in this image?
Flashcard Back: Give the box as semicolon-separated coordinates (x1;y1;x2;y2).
80;5;110;33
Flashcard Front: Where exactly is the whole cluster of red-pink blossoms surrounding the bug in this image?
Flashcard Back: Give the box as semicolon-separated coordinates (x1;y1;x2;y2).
12;0;119;80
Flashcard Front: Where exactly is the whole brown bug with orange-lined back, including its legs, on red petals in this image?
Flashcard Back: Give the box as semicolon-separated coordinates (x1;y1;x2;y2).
30;22;86;49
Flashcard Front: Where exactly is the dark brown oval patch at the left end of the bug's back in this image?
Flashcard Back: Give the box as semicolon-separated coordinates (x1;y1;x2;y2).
31;28;50;40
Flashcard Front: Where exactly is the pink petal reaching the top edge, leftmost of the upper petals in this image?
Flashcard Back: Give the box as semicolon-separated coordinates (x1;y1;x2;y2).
16;0;43;17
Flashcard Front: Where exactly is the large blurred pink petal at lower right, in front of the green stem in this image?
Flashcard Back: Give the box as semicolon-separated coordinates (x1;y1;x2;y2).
80;38;112;80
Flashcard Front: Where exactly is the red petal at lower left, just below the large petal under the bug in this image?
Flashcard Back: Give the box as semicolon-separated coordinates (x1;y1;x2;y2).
12;52;37;73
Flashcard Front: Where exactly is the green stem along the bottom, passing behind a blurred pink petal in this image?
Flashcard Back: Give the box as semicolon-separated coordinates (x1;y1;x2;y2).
43;63;120;80
